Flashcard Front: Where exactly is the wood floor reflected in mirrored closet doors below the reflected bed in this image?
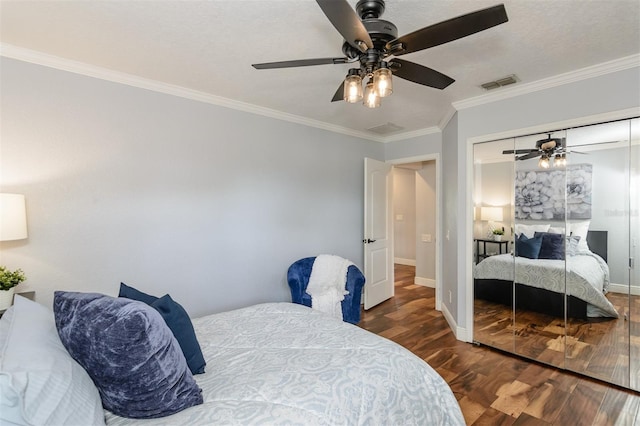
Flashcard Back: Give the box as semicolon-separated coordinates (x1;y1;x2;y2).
474;293;640;387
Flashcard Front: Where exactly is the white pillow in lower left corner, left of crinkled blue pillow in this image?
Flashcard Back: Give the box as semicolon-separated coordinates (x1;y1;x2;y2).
0;295;104;425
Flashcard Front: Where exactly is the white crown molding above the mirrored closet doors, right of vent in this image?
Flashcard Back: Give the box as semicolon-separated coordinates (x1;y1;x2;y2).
452;54;640;111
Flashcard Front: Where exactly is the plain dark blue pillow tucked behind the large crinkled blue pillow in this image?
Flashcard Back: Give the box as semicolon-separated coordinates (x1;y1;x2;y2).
118;283;207;374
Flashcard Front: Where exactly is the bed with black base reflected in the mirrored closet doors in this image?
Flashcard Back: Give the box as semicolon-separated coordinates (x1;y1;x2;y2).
474;230;618;318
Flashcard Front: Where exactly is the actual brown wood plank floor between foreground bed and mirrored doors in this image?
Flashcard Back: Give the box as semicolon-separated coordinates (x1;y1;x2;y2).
359;265;640;426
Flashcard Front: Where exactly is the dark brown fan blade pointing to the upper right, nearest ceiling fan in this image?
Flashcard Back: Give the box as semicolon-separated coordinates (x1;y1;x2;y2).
387;4;509;56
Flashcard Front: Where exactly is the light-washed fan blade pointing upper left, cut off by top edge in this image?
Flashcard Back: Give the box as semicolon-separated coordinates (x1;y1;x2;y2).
316;0;373;52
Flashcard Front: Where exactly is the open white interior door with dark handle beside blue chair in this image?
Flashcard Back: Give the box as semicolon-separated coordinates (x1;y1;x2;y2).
363;158;394;309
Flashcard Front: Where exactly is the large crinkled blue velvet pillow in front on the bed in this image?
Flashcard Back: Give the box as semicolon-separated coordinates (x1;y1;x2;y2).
53;291;202;419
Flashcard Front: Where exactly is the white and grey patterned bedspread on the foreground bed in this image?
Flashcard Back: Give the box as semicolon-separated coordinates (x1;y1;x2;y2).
106;303;464;425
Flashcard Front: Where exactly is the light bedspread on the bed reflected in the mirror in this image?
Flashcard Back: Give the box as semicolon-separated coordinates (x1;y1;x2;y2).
473;251;618;318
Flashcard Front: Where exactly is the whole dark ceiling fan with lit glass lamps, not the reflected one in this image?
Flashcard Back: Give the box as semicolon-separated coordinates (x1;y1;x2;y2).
252;0;509;108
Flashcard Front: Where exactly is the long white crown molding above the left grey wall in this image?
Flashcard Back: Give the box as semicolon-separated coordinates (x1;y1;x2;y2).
0;43;385;142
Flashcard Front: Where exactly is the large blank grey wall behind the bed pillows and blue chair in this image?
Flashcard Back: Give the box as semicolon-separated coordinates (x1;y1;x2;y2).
0;58;384;316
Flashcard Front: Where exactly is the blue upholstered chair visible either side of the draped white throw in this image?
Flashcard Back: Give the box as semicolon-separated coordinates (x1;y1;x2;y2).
287;256;365;324
